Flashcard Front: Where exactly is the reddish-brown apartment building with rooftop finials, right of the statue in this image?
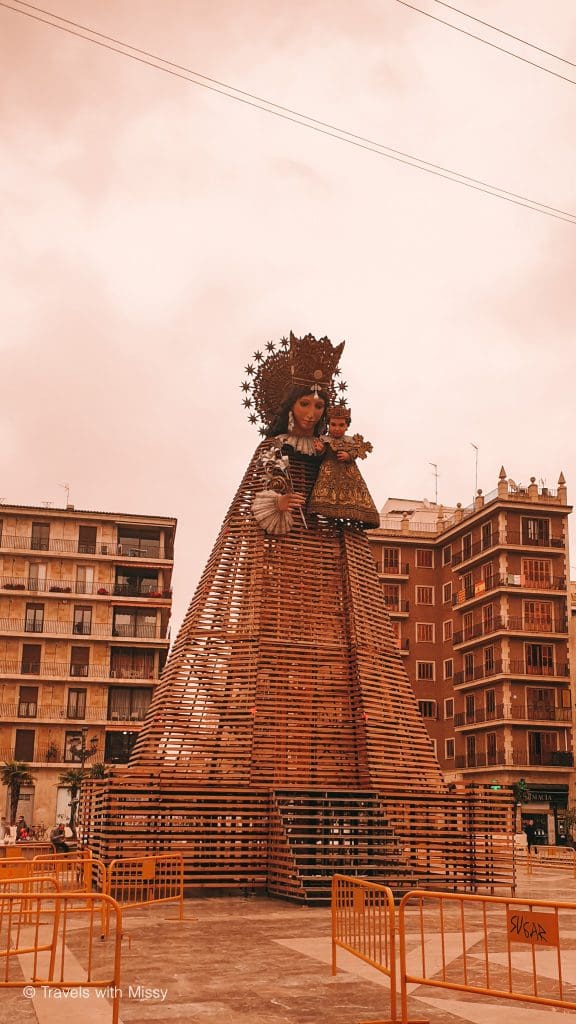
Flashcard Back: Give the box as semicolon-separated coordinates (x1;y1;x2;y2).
369;469;574;843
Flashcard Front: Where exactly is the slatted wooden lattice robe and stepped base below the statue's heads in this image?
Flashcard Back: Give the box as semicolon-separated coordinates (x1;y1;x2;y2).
84;440;511;899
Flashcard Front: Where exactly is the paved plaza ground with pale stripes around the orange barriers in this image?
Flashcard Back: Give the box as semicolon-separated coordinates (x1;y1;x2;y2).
6;868;576;1024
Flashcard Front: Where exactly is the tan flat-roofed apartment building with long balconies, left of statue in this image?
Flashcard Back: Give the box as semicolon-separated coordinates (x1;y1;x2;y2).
0;505;176;826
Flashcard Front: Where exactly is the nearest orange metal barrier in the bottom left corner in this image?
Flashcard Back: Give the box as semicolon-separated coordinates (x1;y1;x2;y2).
0;880;122;1024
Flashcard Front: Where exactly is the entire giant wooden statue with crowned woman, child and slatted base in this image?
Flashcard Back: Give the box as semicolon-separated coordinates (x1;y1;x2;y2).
86;335;510;897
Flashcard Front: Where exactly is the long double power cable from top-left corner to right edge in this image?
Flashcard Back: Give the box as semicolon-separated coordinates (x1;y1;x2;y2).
0;0;576;224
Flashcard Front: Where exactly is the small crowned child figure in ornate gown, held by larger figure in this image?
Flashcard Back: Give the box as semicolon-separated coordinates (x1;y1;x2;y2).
307;406;380;529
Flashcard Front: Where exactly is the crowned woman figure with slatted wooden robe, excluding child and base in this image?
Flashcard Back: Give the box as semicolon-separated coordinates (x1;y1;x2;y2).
130;335;442;793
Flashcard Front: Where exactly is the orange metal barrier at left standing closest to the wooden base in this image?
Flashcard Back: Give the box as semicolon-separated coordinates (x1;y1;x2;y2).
105;853;184;934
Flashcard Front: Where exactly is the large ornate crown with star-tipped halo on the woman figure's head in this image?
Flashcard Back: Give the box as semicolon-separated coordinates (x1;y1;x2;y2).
240;332;347;434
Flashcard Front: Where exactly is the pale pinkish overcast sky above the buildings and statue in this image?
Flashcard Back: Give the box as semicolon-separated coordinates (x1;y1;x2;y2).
0;0;576;627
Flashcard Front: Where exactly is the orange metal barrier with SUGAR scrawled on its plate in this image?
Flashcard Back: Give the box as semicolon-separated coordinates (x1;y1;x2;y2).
399;890;576;1024
